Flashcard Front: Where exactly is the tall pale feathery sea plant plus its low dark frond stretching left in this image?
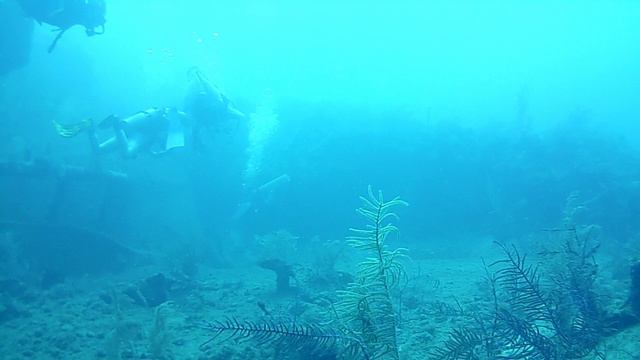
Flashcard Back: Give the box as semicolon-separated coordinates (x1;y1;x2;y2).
202;187;408;359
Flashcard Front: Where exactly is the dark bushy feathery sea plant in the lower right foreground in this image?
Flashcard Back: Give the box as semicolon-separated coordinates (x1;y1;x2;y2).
431;228;605;360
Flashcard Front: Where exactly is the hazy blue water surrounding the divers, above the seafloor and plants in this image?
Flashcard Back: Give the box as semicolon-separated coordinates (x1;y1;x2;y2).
0;0;640;359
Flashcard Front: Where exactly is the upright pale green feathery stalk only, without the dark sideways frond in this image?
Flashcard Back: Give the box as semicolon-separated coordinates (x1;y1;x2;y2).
334;186;408;360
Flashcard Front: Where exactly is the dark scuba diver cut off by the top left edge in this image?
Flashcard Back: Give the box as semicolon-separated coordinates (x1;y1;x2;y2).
17;0;106;52
